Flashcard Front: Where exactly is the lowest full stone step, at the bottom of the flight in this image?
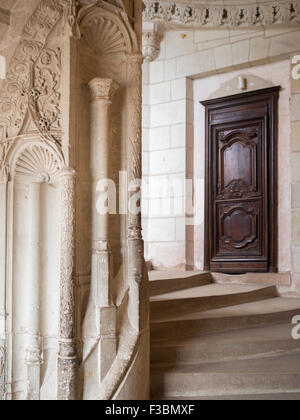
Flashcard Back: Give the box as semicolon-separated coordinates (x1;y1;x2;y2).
151;353;300;399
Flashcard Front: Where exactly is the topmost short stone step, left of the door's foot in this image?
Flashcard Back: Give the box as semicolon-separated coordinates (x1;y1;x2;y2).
149;270;212;296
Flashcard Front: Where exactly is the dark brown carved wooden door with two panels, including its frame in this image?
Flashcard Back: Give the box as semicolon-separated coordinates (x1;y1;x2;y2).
202;87;280;273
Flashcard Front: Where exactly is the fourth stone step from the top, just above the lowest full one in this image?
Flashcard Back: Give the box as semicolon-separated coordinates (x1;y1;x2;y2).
151;324;300;368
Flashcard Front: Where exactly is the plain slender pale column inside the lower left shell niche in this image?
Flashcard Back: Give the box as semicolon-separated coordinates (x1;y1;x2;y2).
25;182;42;401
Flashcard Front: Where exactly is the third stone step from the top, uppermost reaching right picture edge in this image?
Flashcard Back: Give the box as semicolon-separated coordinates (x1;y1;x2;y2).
151;297;300;342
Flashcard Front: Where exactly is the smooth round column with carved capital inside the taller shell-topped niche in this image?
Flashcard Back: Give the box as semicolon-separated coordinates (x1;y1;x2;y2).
89;78;118;383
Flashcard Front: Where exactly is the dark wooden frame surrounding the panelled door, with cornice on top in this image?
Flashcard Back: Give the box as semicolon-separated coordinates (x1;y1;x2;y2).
200;86;281;274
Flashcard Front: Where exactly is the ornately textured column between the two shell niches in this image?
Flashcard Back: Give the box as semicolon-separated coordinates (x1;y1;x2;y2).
58;168;79;400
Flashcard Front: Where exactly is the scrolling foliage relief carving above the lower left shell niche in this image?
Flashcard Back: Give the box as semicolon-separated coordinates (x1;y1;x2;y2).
0;0;63;141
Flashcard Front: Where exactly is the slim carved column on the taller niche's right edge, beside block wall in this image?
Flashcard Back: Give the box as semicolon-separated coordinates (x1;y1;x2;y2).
127;54;144;331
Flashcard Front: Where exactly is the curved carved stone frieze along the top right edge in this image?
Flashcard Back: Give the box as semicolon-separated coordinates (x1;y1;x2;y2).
143;0;300;27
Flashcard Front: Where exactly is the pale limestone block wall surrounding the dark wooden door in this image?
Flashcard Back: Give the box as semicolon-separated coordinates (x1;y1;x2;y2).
143;25;300;278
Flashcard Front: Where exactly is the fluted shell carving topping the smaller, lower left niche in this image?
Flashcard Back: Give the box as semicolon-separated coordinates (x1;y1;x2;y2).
15;145;62;183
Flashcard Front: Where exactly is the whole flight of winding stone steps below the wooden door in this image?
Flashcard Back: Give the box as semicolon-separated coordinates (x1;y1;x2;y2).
149;271;300;400
